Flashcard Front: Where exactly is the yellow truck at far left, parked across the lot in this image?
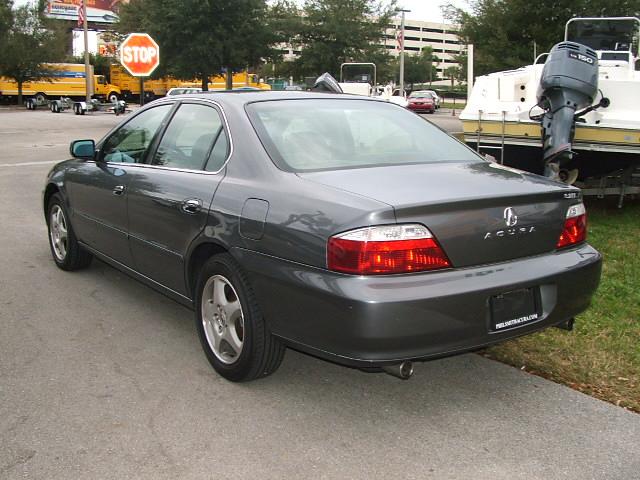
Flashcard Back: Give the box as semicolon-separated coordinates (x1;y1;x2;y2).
0;63;122;104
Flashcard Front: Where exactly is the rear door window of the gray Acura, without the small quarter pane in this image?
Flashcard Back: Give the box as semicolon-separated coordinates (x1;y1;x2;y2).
152;103;224;170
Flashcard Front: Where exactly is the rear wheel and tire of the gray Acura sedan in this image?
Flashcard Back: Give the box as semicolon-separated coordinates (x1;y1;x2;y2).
195;253;285;382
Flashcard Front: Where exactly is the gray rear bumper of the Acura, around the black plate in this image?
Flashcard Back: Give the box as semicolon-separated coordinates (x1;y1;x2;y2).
234;245;602;367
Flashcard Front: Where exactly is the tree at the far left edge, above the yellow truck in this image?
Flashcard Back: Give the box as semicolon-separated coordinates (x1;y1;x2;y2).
0;1;62;104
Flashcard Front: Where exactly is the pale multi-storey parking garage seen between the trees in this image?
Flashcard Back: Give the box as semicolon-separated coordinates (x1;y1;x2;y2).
382;18;466;77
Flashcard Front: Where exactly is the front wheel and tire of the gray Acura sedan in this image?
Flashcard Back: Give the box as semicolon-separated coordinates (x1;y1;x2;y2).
47;193;93;271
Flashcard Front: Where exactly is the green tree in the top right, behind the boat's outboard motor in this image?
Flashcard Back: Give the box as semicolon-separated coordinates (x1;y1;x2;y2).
445;0;640;75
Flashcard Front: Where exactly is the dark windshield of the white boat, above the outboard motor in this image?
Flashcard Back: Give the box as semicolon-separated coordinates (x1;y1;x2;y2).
566;18;638;55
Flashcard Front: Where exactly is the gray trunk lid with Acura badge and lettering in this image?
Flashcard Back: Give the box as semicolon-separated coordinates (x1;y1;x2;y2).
298;162;579;267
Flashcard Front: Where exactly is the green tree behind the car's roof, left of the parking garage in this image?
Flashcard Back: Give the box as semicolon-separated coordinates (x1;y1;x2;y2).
294;0;396;77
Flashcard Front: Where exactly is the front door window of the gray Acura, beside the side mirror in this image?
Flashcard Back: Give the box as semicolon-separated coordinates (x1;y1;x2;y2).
101;104;173;163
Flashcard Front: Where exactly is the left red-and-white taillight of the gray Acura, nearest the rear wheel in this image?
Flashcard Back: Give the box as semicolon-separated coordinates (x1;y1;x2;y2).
327;224;451;275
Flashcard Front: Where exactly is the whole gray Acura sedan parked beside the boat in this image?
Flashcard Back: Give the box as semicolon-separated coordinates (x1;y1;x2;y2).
43;92;601;381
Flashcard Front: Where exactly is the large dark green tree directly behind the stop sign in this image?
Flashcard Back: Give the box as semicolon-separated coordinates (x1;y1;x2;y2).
119;0;286;90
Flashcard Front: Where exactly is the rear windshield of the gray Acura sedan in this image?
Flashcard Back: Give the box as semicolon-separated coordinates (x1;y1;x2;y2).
247;99;480;171
